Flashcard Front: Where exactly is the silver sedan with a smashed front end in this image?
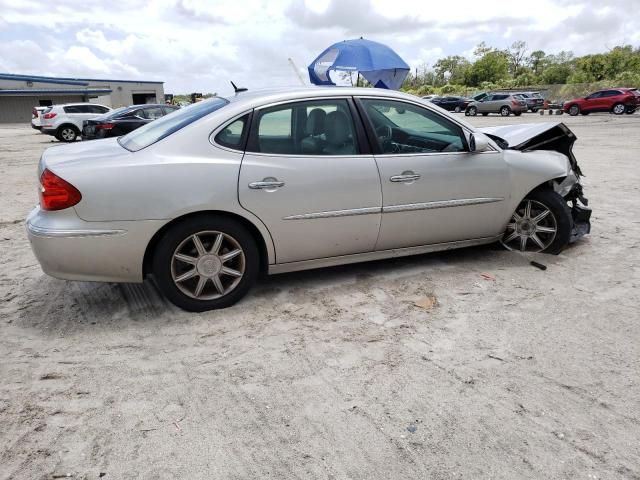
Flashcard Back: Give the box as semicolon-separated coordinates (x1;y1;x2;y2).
27;88;590;311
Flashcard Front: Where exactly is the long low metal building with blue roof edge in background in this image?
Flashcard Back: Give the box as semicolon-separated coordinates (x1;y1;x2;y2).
0;73;164;123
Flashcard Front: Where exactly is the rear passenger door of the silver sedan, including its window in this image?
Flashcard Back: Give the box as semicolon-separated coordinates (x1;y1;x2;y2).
238;98;382;263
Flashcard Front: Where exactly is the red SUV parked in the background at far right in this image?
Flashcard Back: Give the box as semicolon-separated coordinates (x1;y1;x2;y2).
562;88;640;116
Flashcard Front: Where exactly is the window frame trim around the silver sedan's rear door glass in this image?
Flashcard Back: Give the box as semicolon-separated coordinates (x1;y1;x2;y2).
245;95;372;157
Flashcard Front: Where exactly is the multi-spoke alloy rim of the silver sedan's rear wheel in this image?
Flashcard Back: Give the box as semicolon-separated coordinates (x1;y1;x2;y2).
171;230;246;300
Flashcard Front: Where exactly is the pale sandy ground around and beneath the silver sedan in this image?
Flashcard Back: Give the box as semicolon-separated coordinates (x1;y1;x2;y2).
0;114;640;480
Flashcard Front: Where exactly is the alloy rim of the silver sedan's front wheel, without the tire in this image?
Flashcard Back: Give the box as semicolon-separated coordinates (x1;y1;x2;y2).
501;199;558;252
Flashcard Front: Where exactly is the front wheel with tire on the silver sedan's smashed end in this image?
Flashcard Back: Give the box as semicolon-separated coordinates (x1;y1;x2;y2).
501;188;573;255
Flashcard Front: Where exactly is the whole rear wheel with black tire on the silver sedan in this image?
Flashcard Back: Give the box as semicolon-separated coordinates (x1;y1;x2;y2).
152;215;260;312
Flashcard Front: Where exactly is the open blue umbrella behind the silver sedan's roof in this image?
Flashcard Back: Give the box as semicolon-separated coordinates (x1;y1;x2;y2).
308;38;409;90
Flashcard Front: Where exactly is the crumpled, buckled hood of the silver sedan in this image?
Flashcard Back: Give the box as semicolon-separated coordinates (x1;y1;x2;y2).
478;122;582;176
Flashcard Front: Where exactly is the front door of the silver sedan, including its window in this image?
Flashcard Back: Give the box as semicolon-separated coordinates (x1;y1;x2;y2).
361;99;509;250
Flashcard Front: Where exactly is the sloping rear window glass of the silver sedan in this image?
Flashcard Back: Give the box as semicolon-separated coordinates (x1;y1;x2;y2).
118;97;229;152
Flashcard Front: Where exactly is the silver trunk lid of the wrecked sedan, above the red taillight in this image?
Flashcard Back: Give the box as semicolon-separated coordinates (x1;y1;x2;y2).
39;138;131;175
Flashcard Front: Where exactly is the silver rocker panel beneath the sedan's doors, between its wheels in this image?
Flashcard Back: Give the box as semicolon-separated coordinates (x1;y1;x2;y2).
269;235;502;275
